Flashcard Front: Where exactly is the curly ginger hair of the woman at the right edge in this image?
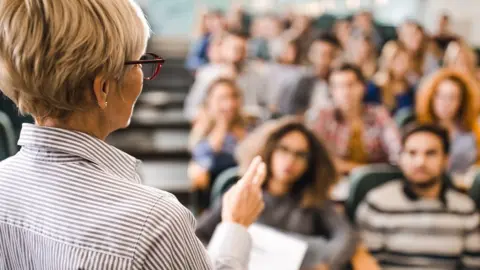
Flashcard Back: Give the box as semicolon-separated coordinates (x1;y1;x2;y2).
416;68;480;131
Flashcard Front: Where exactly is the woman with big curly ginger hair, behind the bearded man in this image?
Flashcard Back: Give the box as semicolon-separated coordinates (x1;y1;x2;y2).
416;69;480;177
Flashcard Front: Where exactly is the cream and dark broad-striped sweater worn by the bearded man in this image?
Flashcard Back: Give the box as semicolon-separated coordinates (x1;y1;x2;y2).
356;180;480;270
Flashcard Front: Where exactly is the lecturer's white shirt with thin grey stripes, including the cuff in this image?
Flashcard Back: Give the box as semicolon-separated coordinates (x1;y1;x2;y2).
0;124;251;270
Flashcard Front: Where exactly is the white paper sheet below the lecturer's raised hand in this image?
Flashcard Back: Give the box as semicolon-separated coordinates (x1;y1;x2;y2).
248;224;308;270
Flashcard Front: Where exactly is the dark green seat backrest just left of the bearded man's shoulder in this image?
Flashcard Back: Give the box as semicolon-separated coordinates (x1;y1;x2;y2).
345;164;403;221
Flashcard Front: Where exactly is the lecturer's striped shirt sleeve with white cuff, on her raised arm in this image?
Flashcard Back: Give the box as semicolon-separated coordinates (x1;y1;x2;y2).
134;196;251;270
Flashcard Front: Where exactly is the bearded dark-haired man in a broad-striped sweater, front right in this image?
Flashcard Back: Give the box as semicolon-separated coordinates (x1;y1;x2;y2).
356;125;480;270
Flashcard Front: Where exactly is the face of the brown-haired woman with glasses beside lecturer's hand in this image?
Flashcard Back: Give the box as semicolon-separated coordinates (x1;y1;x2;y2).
271;131;309;184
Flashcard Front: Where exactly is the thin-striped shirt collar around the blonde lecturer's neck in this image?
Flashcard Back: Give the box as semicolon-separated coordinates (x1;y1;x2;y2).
18;124;140;181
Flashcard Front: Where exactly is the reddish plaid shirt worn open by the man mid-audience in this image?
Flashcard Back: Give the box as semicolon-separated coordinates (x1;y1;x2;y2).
311;105;401;163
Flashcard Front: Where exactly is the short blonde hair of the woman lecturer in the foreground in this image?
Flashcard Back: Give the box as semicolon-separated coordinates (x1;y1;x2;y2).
0;0;150;118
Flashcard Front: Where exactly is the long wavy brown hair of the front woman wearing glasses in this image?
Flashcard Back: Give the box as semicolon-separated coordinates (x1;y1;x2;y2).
237;117;337;207
